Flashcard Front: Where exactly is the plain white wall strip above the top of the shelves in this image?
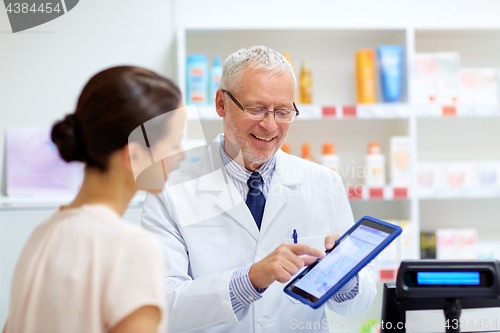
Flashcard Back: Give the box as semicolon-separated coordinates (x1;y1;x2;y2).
176;0;500;29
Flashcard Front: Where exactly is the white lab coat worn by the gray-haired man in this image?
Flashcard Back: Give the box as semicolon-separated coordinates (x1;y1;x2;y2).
142;136;376;333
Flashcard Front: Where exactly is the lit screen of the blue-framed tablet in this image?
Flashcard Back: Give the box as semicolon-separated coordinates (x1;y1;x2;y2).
294;224;390;302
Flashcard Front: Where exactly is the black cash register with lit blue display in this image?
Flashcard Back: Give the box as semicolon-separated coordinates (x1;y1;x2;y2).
381;260;500;333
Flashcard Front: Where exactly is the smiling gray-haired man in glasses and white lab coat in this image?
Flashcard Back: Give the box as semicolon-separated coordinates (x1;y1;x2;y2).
142;46;376;332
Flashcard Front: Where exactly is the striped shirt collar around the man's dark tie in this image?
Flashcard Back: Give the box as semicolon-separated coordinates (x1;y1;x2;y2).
218;134;276;184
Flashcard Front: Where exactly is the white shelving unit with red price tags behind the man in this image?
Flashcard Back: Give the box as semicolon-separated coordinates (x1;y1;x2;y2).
177;22;500;264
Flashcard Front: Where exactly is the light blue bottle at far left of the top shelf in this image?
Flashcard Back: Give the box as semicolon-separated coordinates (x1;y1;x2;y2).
186;54;208;105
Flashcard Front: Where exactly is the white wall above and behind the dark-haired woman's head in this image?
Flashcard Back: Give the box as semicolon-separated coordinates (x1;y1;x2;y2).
0;0;176;193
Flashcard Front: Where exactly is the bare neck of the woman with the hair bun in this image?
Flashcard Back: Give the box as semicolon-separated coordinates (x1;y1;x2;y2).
63;167;136;216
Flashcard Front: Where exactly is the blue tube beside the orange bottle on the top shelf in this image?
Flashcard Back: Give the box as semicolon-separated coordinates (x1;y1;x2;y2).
377;45;403;103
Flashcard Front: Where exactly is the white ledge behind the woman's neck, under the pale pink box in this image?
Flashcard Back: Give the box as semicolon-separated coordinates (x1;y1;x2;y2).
0;191;146;211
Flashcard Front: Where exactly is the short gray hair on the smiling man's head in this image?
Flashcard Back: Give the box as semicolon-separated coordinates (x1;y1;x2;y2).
219;45;297;92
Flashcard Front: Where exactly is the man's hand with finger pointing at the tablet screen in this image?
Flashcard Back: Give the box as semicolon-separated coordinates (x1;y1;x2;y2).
248;244;325;288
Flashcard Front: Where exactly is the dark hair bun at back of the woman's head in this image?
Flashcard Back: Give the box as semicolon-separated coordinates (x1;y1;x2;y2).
52;114;87;162
